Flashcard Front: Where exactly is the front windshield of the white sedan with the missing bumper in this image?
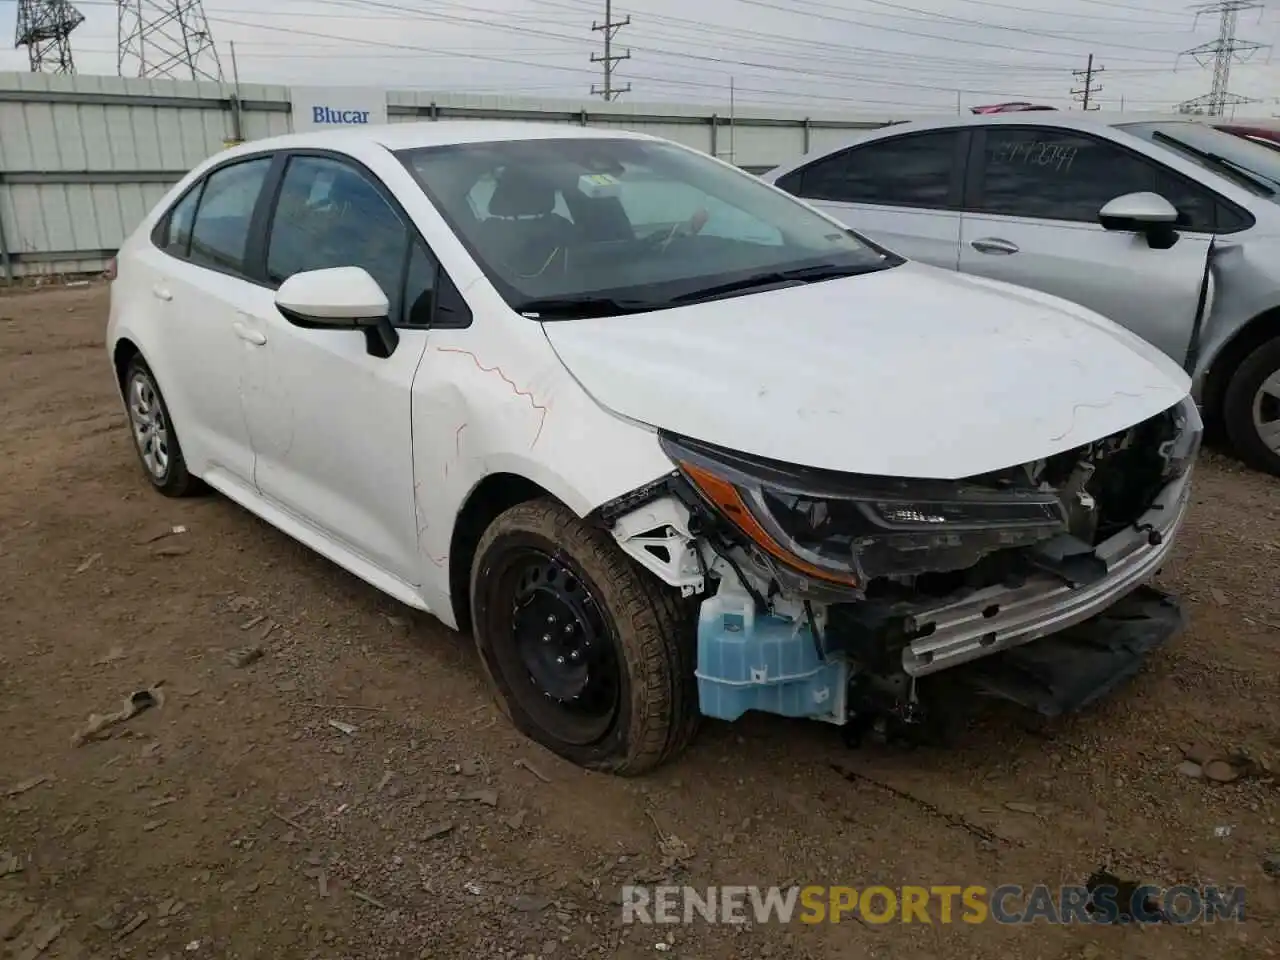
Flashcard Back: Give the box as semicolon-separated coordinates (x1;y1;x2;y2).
399;137;901;320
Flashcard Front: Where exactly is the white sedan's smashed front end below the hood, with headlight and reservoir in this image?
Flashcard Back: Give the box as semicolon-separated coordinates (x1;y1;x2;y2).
613;398;1202;724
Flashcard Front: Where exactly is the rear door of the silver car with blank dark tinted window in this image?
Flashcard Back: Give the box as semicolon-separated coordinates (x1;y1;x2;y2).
762;128;968;270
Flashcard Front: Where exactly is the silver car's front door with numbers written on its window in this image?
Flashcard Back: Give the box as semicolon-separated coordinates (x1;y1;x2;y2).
960;124;1219;362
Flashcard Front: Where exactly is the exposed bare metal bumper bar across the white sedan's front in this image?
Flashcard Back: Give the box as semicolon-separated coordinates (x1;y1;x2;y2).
902;470;1193;677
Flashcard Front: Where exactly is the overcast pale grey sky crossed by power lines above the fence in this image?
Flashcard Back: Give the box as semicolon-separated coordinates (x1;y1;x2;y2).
0;0;1280;116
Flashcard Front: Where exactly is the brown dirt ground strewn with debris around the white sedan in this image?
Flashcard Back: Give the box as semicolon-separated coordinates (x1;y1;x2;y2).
0;284;1280;960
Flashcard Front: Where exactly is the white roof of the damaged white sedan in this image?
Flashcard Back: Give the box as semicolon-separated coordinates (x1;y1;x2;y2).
224;120;654;158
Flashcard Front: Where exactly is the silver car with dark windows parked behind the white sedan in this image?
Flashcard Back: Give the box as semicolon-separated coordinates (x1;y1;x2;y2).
764;113;1280;475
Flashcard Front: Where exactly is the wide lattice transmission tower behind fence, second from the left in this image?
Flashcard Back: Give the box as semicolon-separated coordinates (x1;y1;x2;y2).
115;0;223;81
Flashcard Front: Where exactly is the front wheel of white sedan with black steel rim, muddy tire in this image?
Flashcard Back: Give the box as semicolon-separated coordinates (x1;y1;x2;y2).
471;499;700;776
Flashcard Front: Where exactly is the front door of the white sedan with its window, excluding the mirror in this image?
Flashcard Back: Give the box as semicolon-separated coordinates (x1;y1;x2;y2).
241;155;428;586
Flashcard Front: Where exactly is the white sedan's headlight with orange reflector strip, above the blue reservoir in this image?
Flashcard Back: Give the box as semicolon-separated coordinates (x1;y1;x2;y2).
663;438;1066;586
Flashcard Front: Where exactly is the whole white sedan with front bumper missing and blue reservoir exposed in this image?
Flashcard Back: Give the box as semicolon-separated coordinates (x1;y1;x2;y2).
108;123;1202;774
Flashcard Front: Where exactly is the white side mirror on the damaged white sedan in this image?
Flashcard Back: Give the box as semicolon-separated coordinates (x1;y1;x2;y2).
275;266;399;357
